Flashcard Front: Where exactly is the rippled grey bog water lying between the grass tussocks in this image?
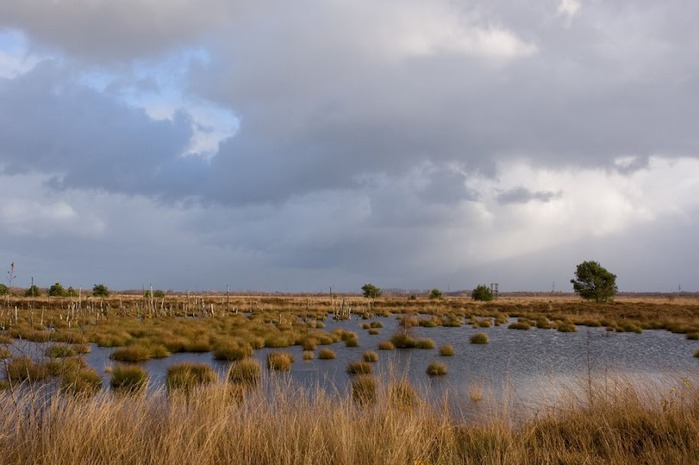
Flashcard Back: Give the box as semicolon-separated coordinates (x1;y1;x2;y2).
6;316;699;405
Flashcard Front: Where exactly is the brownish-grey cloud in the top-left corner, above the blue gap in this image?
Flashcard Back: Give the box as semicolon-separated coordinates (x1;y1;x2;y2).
0;0;233;64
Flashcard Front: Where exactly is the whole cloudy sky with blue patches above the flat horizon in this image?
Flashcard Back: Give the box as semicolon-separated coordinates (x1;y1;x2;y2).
0;0;699;292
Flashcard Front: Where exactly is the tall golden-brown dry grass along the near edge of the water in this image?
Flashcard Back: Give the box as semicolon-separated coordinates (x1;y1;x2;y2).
0;381;699;465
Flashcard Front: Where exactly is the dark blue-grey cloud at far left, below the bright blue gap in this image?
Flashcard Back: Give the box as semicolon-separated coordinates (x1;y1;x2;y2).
0;61;206;200
